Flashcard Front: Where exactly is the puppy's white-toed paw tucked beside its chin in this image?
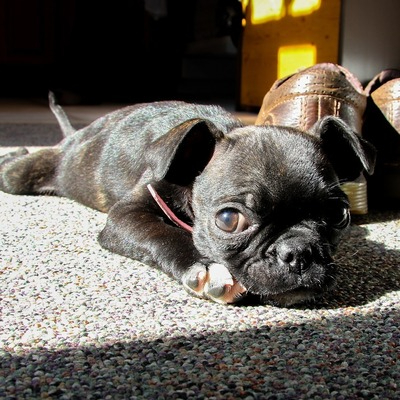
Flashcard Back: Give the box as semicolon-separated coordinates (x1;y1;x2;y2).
182;263;246;304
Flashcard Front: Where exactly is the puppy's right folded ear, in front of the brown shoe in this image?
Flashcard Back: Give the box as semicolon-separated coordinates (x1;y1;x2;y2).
311;116;376;181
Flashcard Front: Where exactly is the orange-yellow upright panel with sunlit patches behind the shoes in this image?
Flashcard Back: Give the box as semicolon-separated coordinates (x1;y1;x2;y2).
238;0;341;109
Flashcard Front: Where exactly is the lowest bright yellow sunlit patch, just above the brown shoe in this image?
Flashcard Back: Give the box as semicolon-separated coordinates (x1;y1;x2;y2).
278;44;317;79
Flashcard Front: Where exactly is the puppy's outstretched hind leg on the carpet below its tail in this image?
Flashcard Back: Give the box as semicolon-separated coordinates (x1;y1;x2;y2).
0;148;61;194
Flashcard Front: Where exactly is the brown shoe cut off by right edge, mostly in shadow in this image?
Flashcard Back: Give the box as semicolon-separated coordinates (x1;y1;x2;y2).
363;69;400;207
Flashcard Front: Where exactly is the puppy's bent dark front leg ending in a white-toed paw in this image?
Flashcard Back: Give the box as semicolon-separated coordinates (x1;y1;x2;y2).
99;194;246;304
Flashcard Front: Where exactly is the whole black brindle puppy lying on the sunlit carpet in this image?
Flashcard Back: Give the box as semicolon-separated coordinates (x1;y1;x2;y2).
0;95;374;306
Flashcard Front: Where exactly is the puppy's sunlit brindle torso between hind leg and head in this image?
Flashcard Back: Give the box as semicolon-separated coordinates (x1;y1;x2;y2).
47;102;240;212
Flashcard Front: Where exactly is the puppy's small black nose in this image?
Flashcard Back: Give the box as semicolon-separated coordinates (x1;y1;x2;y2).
276;242;312;274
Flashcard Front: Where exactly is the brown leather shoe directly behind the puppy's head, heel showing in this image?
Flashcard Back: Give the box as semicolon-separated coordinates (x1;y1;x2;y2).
256;63;368;214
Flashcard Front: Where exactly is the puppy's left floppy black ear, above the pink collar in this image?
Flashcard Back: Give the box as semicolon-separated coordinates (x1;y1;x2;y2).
146;118;224;186
